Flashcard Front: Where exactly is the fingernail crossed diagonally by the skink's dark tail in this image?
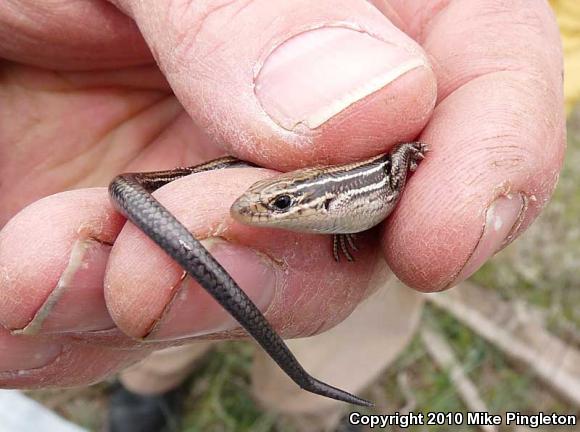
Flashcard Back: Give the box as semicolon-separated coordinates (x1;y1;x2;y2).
146;238;282;341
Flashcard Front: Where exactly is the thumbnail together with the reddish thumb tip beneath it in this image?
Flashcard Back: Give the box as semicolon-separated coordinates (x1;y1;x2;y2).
255;26;436;163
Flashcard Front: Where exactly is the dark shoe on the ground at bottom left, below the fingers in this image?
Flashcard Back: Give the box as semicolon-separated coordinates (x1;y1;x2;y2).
107;384;185;432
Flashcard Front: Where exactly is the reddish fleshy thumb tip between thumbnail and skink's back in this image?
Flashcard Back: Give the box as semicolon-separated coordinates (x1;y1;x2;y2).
284;64;437;170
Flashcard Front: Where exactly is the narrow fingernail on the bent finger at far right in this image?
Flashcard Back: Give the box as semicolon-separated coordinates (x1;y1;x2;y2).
448;194;524;286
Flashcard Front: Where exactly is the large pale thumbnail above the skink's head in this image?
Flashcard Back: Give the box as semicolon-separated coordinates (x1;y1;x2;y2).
255;27;426;130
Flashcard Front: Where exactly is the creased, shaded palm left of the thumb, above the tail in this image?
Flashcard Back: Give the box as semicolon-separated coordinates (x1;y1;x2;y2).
0;65;205;226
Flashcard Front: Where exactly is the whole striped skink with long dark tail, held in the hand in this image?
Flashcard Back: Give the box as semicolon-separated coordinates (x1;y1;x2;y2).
109;142;427;406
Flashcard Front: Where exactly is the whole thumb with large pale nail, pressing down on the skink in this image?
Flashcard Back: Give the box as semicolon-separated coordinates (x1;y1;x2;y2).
107;0;436;169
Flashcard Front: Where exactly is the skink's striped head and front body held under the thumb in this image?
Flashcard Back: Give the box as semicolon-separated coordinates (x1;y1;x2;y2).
230;142;428;261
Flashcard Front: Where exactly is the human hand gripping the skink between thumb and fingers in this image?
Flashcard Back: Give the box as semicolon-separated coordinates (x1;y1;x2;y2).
0;0;564;387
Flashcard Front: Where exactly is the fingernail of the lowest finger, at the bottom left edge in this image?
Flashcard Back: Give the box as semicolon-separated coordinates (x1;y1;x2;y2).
0;336;62;372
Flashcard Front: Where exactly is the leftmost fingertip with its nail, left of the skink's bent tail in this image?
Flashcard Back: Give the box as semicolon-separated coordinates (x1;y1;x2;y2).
0;188;123;333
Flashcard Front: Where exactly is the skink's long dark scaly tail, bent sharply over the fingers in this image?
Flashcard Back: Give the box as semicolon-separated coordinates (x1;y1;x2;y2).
109;158;372;406
